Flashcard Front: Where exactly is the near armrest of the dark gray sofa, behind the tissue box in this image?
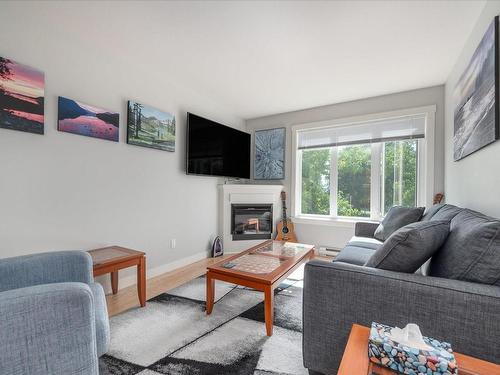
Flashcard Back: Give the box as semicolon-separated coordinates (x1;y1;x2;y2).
303;261;500;374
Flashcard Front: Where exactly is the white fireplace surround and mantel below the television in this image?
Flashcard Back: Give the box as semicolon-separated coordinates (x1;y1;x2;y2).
219;184;283;253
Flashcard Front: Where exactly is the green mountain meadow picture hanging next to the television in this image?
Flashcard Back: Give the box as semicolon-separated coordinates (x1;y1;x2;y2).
127;101;175;152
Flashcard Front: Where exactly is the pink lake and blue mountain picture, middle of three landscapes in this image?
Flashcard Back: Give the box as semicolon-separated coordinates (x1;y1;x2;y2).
57;96;120;142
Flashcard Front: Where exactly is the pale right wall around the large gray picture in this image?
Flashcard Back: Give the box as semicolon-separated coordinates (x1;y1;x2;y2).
445;1;500;217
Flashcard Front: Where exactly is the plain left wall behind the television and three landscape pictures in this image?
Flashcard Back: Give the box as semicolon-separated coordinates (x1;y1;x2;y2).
0;2;244;292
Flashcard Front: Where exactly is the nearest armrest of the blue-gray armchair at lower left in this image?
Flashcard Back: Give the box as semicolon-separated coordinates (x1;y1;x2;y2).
0;283;99;375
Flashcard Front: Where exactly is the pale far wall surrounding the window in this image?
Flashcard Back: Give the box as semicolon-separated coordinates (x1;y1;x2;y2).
246;86;444;248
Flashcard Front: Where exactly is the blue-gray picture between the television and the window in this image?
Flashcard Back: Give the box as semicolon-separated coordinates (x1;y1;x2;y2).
254;128;286;180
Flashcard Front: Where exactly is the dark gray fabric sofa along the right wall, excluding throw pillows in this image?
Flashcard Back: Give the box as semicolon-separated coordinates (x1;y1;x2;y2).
303;205;500;374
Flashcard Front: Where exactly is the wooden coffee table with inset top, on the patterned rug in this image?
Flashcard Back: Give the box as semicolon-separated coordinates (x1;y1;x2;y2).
207;240;314;336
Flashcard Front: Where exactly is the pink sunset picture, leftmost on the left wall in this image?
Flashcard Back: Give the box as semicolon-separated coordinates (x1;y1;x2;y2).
0;57;45;134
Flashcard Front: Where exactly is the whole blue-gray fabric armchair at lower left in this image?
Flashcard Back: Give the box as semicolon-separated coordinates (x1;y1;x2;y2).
0;251;109;375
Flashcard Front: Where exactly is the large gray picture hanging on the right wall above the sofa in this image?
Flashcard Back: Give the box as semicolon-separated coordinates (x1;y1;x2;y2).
453;17;499;161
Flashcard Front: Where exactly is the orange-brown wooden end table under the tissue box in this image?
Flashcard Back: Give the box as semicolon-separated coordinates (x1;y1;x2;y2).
337;324;500;375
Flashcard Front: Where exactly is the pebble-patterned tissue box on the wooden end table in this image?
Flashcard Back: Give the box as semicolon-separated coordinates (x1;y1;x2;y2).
368;322;458;375
